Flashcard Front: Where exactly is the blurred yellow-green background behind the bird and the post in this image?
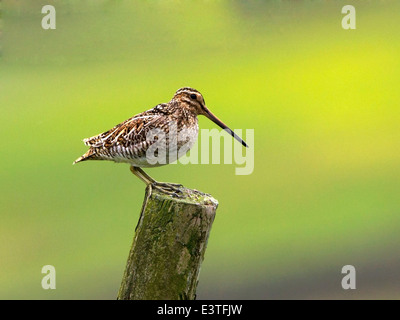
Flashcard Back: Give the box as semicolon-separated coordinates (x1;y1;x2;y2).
0;0;400;299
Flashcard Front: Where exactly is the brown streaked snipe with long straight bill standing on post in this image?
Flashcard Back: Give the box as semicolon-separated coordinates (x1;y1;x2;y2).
73;87;248;196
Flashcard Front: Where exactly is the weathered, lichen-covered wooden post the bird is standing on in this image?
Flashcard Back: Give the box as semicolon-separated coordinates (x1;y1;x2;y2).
118;186;218;300
